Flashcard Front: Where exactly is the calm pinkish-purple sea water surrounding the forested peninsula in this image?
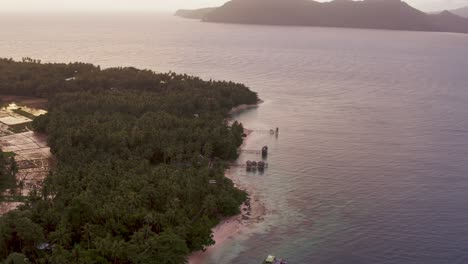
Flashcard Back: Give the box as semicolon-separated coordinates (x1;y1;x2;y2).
0;14;468;264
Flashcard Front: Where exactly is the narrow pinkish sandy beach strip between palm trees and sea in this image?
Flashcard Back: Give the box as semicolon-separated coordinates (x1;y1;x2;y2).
188;100;266;264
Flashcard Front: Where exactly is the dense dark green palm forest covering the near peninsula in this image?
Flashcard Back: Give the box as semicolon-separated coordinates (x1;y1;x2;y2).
0;58;258;264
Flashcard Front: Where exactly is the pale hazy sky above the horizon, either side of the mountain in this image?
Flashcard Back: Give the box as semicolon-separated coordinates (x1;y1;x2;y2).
0;0;468;12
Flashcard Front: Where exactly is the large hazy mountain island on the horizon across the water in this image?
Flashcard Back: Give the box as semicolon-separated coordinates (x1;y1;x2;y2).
178;0;468;33
